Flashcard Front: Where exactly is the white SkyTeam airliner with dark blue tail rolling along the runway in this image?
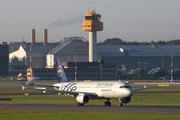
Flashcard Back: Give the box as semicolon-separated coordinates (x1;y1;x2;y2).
22;59;146;106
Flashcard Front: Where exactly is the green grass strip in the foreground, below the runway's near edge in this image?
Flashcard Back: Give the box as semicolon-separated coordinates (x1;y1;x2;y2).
0;110;180;120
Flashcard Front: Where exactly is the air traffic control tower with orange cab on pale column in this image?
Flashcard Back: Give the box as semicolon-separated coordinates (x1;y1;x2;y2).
82;9;103;62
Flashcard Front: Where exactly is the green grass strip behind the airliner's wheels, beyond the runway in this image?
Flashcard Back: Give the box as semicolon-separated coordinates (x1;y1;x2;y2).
0;93;180;106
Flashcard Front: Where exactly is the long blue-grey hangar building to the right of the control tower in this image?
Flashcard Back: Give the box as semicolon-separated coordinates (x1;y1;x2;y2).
98;44;180;72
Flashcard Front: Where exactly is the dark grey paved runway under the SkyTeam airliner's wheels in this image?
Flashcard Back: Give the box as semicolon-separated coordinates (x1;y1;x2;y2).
0;104;180;114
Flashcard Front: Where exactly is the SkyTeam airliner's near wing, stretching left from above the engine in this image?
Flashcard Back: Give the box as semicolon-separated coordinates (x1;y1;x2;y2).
34;87;97;96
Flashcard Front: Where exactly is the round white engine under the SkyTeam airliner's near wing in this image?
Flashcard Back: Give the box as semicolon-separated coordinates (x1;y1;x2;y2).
76;94;89;104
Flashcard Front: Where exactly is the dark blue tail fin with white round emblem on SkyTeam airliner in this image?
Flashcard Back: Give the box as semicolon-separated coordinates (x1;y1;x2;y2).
56;59;69;83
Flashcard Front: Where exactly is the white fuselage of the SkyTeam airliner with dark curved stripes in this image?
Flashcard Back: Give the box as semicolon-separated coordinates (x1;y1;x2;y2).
53;82;133;98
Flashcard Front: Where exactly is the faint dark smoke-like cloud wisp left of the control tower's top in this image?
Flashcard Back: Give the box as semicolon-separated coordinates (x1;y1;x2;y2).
49;13;84;27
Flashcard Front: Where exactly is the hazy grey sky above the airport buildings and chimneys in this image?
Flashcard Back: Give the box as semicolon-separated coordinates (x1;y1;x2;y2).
0;0;180;42
